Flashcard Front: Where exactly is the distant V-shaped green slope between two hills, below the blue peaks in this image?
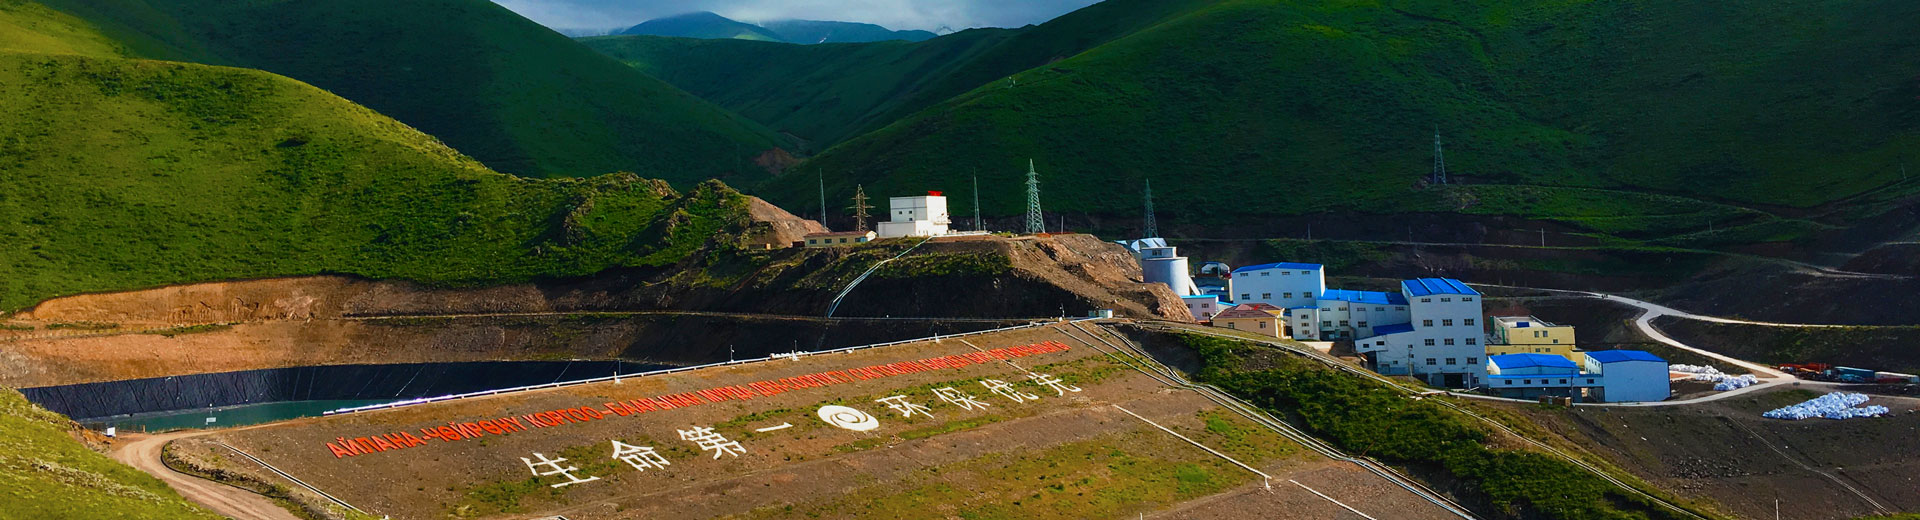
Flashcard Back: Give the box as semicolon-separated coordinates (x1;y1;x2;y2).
582;0;1206;148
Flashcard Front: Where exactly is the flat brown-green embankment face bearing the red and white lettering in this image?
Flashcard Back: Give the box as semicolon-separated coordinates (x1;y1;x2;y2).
194;326;1450;520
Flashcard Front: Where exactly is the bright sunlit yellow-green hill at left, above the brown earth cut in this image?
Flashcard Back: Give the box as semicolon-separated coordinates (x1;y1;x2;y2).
0;0;747;309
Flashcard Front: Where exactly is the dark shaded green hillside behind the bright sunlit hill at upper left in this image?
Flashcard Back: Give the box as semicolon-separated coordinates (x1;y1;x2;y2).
31;0;783;186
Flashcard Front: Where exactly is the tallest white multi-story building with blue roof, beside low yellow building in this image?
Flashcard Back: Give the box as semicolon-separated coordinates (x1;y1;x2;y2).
1354;278;1486;388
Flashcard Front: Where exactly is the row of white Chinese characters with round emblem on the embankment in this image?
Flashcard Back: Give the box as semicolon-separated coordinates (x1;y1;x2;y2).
520;374;1081;487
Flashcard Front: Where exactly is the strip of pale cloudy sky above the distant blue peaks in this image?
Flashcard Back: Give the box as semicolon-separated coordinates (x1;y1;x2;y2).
493;0;1096;31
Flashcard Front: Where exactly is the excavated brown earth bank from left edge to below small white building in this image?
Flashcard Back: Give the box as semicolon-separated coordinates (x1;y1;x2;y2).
0;236;1187;388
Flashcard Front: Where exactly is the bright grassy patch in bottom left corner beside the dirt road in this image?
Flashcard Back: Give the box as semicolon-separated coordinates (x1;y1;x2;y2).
0;388;221;520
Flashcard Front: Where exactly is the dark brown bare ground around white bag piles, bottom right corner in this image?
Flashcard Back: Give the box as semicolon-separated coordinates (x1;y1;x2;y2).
1486;390;1920;520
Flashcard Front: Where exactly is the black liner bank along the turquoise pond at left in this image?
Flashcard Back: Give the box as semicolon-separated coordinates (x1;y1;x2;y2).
19;361;670;422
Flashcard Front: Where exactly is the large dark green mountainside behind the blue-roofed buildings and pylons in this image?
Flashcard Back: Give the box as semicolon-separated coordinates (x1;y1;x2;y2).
762;0;1920;230
